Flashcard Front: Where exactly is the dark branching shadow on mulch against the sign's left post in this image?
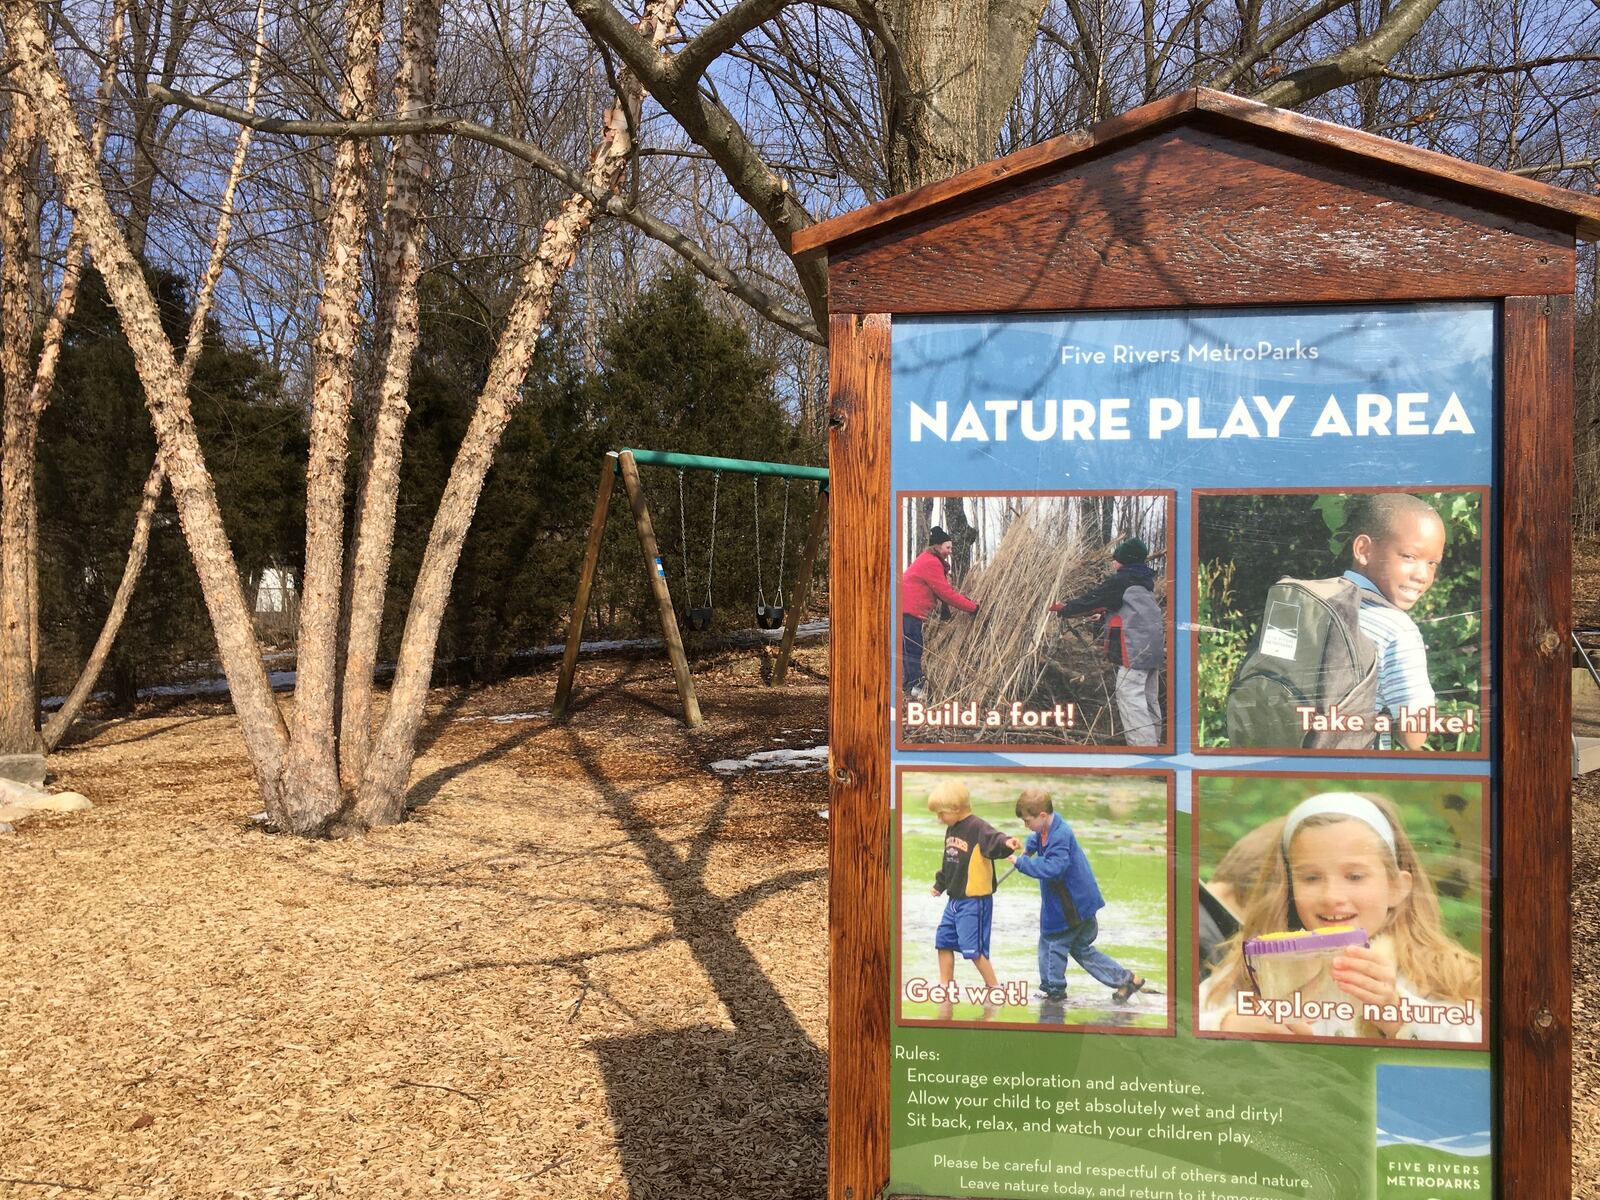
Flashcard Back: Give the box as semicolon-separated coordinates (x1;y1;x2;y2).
570;736;827;1200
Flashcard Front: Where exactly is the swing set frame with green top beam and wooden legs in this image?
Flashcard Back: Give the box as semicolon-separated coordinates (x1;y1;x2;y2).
552;450;827;726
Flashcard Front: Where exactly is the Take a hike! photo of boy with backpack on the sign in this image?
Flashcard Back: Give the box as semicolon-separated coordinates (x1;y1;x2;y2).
1194;488;1488;757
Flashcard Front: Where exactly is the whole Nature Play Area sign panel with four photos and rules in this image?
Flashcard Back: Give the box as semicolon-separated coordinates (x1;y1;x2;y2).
890;304;1499;1200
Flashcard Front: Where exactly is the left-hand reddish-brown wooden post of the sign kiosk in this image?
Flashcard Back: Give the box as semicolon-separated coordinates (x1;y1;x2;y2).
827;312;894;1200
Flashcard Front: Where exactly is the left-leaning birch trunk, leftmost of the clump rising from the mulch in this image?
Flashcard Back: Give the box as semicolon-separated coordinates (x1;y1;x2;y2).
0;0;290;812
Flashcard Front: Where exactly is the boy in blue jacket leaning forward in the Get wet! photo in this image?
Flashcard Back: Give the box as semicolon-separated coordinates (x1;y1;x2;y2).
1011;787;1149;1005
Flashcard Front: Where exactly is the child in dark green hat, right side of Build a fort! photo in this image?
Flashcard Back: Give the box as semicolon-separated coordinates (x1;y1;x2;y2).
1050;538;1166;746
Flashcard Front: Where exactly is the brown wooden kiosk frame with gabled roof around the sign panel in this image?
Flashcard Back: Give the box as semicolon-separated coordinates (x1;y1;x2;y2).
795;90;1600;1200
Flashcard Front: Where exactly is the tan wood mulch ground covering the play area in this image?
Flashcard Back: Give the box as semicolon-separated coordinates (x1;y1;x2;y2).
0;630;1600;1200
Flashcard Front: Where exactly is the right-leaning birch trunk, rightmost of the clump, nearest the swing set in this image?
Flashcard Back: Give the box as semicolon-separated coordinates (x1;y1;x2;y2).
355;0;682;826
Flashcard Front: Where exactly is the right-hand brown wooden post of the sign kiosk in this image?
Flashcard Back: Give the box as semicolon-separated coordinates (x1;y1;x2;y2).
1494;294;1573;1200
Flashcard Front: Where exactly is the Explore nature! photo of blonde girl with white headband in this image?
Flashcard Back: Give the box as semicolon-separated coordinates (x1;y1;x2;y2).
1194;774;1488;1046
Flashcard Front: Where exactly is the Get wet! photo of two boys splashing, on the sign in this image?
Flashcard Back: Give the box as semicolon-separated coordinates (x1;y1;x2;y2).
898;770;1173;1034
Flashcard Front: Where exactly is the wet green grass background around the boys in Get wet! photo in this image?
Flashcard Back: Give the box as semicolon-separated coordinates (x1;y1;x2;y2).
901;771;1171;1027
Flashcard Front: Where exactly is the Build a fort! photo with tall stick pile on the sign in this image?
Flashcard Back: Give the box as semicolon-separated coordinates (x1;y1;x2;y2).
894;493;1176;750
